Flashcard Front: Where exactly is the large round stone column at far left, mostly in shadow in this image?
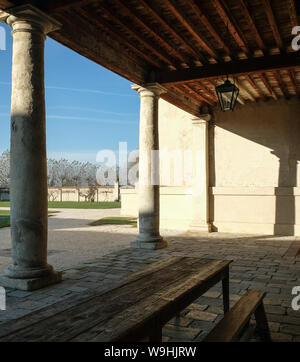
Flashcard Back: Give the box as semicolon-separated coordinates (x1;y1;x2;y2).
0;5;61;290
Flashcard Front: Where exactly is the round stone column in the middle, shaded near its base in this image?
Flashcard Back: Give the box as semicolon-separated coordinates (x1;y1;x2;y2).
132;83;167;249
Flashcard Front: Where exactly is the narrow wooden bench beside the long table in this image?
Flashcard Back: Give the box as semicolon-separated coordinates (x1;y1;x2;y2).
203;290;271;342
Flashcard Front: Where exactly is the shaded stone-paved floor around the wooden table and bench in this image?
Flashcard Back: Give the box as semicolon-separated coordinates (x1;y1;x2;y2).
0;233;300;342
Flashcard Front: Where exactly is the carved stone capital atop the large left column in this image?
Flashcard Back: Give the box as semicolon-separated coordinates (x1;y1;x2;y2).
0;4;61;34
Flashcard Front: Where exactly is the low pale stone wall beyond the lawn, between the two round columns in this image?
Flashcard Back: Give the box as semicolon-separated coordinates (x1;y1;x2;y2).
48;183;119;202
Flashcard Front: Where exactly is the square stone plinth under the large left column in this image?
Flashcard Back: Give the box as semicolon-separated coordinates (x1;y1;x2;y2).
0;272;62;291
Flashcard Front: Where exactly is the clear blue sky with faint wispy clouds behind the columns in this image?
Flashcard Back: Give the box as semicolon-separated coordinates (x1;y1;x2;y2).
0;24;139;162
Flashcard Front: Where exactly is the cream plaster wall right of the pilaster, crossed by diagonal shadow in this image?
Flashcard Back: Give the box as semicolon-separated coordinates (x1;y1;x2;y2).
210;99;300;235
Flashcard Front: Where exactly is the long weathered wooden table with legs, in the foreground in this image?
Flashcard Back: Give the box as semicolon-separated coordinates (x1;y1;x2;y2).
0;256;231;342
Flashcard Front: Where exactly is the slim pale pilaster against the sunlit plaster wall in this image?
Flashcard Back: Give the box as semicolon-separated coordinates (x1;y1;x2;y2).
190;114;211;232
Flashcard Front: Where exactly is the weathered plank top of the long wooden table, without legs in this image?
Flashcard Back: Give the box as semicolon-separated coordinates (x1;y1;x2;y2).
0;257;230;341
